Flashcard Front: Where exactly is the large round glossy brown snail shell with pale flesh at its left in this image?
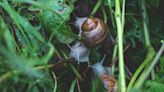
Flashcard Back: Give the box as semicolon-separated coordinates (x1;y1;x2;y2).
75;17;109;48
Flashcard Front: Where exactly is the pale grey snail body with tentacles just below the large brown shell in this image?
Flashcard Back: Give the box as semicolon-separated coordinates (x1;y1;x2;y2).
68;41;90;64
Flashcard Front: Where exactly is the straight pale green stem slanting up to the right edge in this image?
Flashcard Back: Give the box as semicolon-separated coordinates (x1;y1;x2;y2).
134;43;164;89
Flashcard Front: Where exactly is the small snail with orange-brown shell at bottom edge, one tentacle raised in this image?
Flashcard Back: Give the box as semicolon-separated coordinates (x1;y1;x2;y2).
90;55;117;92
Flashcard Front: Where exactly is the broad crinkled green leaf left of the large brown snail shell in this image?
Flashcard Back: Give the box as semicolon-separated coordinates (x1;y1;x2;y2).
37;0;78;44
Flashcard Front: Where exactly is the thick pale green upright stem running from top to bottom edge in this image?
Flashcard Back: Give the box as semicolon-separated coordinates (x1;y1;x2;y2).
115;0;126;92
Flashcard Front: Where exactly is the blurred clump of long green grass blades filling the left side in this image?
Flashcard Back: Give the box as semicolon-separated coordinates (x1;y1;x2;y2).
0;0;54;92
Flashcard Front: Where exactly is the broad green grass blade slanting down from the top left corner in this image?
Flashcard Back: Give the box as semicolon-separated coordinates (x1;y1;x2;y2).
0;0;45;56
